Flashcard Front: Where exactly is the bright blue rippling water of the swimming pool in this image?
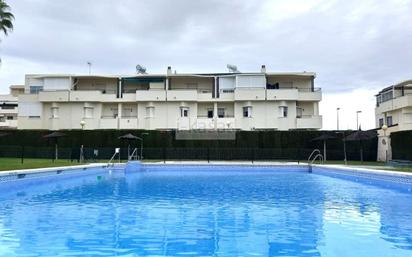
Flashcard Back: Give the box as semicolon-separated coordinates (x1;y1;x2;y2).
0;165;412;257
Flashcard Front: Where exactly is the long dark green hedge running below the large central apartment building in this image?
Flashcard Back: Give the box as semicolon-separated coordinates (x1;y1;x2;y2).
0;130;377;161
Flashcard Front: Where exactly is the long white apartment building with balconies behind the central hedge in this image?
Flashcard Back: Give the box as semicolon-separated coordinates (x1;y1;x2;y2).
18;65;322;130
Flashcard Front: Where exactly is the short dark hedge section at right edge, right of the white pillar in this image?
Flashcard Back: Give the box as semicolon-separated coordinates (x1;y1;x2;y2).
391;130;412;161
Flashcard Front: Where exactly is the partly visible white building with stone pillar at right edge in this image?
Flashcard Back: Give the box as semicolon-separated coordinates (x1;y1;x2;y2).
375;80;412;161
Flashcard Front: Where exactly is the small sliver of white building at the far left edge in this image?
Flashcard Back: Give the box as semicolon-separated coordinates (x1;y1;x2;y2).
0;85;24;129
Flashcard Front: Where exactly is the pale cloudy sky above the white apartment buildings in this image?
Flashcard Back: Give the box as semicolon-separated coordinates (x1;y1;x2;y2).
0;0;412;129
